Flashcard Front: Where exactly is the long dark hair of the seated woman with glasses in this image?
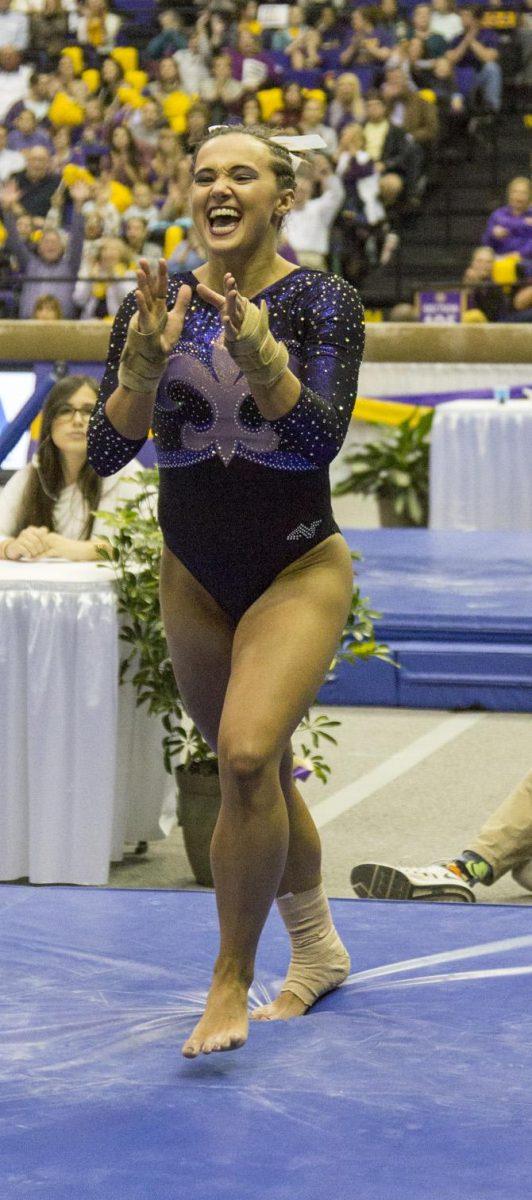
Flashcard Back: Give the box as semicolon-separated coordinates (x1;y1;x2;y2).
14;376;102;540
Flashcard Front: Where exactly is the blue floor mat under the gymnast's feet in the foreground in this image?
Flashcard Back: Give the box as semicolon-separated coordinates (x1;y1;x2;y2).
0;886;532;1200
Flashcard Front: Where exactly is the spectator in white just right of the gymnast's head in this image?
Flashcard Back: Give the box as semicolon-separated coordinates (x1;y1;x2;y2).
283;155;346;271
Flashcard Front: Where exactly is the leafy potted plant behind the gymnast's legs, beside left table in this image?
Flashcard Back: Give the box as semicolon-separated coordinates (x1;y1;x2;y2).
97;469;391;887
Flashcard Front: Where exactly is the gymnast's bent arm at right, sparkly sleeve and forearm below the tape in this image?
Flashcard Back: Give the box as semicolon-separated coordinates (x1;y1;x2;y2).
258;276;364;467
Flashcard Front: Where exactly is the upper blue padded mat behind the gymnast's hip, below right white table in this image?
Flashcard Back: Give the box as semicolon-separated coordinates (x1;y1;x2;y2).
342;529;532;641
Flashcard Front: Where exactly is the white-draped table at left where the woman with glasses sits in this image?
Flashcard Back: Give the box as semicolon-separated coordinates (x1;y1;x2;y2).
0;560;174;884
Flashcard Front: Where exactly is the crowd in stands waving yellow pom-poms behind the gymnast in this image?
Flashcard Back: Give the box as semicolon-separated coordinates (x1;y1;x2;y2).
0;0;532;320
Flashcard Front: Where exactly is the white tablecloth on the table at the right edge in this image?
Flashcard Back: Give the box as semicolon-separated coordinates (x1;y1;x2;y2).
429;400;532;530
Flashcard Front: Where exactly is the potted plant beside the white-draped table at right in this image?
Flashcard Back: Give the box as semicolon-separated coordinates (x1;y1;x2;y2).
334;409;434;526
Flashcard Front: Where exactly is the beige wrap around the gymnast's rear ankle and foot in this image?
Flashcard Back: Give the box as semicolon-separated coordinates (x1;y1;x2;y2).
277;883;351;1006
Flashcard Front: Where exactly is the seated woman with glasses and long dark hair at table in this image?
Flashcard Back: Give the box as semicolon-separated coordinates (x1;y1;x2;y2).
0;376;142;563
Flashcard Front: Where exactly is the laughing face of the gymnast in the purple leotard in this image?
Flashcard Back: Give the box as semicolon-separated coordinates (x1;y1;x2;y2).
191;133;294;256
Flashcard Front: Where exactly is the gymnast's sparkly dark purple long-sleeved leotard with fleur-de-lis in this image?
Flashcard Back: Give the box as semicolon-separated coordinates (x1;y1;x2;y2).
88;268;364;620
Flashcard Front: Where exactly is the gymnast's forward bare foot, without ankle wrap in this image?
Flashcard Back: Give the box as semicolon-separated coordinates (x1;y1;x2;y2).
183;982;249;1058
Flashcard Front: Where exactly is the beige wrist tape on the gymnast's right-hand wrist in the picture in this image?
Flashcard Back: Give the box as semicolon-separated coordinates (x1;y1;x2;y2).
225;298;288;388
